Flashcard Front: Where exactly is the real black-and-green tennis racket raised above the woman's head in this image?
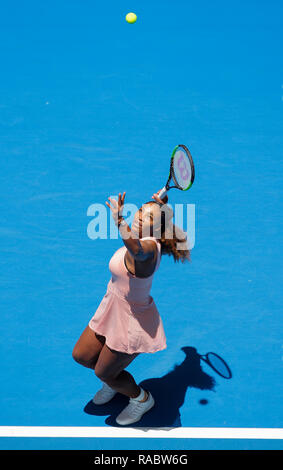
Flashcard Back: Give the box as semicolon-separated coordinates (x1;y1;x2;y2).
158;145;195;198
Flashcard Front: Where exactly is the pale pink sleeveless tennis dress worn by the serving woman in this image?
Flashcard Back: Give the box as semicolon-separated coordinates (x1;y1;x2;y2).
89;237;167;354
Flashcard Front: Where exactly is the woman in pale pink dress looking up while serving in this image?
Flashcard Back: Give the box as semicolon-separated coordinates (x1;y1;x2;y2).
73;191;190;425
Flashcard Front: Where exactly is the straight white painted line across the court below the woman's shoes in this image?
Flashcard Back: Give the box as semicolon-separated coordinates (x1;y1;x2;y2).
0;426;283;439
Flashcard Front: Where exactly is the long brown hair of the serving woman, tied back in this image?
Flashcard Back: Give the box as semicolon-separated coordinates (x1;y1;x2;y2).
145;201;191;263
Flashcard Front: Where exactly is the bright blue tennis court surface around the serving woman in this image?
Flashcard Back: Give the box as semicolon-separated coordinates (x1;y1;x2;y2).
0;0;283;449
